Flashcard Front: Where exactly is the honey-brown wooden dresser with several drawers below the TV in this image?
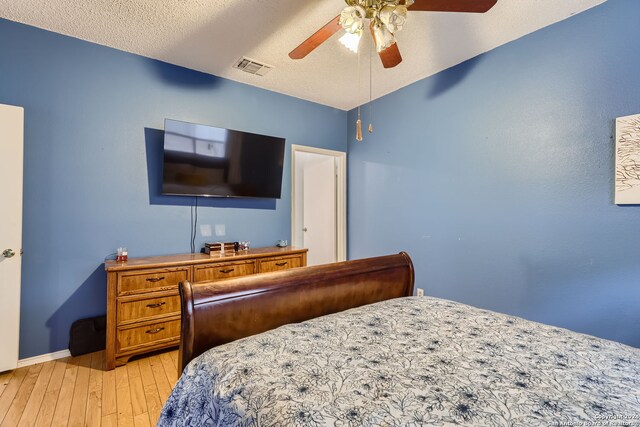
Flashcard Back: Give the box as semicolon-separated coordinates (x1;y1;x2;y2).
105;247;307;369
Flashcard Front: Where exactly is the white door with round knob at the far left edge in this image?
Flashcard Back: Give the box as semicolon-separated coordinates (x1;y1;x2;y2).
0;104;24;372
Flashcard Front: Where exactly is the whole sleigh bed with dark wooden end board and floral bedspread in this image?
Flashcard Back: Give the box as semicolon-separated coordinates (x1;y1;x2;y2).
158;253;640;427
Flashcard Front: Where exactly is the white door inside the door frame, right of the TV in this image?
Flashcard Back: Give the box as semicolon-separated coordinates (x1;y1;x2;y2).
302;154;337;265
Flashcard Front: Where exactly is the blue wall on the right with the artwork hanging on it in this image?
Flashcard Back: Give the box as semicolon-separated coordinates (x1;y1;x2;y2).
348;0;640;347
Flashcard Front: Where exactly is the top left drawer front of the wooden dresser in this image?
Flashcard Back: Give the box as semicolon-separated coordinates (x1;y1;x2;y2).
118;267;189;294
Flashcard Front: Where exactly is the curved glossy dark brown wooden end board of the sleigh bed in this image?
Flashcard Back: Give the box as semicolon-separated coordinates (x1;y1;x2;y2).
178;252;414;374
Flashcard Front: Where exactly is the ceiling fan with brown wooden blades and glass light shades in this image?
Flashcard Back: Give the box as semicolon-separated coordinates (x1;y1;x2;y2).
289;0;498;68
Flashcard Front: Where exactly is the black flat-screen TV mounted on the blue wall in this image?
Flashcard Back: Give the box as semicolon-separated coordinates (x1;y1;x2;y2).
162;119;285;199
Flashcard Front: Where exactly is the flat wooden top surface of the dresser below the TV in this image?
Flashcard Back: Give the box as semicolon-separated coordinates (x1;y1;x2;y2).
104;246;307;271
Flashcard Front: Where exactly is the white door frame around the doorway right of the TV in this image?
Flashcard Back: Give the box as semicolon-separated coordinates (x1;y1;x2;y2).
291;144;347;261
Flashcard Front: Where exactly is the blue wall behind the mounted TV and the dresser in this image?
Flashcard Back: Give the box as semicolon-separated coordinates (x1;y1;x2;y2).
0;20;346;358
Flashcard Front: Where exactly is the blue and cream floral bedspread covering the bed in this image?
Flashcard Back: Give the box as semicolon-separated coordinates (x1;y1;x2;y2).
158;297;640;427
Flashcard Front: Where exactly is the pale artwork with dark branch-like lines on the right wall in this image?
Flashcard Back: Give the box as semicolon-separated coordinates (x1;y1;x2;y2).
615;114;640;205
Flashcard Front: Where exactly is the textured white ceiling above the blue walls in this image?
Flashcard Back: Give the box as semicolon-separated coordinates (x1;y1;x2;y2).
0;0;605;110
